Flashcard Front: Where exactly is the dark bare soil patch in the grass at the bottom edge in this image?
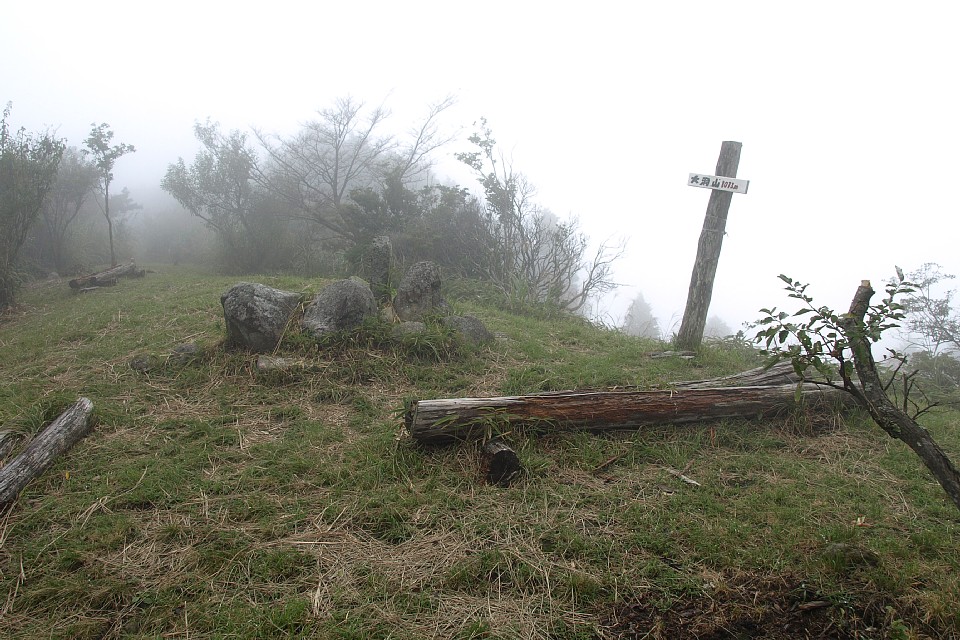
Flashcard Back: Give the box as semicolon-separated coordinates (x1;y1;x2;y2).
603;574;896;640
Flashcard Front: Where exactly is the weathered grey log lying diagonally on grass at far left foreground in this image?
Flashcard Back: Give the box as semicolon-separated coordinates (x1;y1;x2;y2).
0;398;93;508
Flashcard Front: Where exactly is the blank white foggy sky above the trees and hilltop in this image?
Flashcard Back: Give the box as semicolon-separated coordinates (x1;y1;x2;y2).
0;0;960;331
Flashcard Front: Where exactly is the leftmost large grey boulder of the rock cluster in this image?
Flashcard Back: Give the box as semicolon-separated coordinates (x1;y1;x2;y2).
220;282;300;353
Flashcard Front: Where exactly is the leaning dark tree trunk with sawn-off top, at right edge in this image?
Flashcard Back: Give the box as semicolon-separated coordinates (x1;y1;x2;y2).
840;280;960;509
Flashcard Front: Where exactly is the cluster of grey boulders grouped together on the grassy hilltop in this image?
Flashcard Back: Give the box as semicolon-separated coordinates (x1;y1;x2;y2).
220;262;493;353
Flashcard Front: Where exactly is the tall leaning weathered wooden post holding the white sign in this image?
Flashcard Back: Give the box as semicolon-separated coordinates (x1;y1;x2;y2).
676;141;743;351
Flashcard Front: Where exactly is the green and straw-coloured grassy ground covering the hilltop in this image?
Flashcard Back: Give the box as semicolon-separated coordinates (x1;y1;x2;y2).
0;267;960;639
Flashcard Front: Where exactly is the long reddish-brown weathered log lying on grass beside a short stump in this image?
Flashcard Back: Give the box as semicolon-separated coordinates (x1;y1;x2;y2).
405;384;846;444
